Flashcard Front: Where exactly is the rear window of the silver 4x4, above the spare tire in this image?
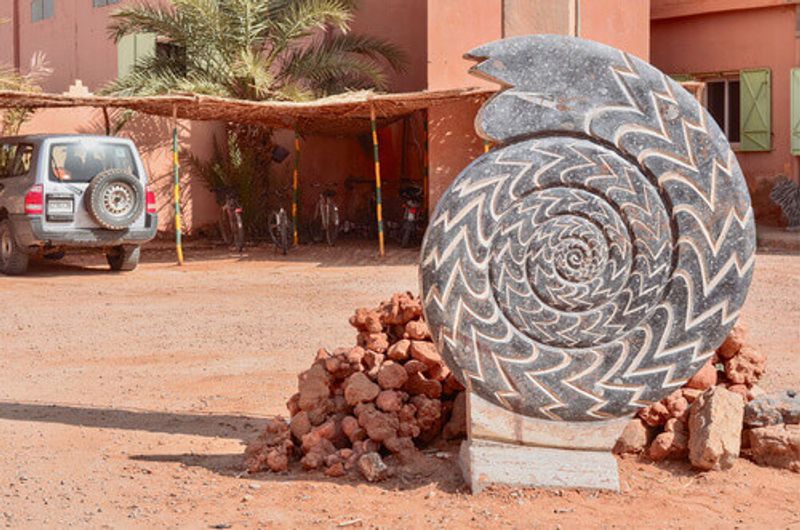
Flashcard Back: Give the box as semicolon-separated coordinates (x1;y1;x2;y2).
50;141;139;182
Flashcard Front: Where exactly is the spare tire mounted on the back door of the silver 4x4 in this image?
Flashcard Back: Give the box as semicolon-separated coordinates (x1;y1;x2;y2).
86;169;145;230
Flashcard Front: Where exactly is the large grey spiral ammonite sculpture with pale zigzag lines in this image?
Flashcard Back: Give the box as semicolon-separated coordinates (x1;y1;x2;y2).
420;35;755;421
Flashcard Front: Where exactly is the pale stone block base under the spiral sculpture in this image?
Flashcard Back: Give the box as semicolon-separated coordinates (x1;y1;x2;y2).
459;393;629;493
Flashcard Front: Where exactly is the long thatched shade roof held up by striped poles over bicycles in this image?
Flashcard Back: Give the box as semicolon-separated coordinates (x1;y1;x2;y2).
0;88;493;134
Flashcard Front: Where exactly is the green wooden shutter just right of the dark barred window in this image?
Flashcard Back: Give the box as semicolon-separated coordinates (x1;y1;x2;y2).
739;68;772;151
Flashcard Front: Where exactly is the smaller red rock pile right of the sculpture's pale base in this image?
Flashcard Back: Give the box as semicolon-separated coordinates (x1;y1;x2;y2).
615;325;766;469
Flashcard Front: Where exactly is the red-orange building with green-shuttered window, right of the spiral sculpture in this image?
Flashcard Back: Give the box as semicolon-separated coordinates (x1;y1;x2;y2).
650;0;800;225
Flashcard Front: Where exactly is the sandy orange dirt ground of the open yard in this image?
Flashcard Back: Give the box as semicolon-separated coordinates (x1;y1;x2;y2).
0;241;800;528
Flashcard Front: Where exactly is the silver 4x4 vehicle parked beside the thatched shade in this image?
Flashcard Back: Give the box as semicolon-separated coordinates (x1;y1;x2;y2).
0;135;158;274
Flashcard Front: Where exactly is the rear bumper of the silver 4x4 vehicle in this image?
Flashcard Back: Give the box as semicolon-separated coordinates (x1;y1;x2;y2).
11;214;158;247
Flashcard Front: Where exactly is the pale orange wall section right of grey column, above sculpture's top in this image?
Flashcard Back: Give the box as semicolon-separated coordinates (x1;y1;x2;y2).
579;0;650;61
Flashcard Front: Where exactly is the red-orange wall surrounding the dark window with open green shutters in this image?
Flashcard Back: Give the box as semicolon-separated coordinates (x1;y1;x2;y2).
651;5;798;224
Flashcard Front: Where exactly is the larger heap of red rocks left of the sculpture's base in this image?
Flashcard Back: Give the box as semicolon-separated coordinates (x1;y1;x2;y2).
245;293;466;481
